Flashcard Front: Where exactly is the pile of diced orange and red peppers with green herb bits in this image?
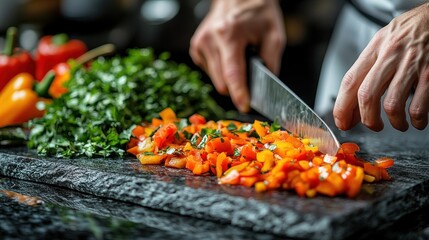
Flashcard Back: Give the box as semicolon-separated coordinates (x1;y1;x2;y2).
127;108;393;198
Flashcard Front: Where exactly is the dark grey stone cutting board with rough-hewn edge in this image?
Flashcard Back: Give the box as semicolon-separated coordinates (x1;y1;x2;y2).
0;122;429;239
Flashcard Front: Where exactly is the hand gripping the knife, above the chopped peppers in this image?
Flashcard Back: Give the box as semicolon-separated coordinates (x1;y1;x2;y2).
189;0;286;112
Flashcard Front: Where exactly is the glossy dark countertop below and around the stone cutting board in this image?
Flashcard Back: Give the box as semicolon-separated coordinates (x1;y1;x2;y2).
0;178;429;240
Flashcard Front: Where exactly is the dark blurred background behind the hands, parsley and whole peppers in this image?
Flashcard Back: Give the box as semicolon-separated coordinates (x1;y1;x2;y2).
0;0;344;109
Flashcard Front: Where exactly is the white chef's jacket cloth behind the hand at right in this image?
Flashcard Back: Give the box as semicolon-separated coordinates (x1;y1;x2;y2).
315;0;427;116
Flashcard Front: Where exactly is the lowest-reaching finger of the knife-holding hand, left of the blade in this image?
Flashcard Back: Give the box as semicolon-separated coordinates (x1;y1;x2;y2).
220;42;250;112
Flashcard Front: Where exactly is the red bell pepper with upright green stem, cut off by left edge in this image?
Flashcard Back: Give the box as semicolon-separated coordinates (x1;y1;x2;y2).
0;27;35;91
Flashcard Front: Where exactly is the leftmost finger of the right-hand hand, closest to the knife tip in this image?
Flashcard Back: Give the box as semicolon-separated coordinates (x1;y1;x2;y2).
333;50;377;130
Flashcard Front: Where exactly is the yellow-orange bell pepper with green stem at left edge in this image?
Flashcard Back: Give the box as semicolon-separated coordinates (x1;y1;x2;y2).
0;73;55;127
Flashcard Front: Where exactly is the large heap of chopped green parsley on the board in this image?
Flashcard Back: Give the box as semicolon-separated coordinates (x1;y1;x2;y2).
28;49;223;157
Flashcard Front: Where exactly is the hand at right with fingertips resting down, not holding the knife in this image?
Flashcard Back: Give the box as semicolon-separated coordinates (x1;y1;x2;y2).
333;4;429;131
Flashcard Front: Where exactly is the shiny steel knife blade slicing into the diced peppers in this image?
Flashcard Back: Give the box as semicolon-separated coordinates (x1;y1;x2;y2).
249;57;340;156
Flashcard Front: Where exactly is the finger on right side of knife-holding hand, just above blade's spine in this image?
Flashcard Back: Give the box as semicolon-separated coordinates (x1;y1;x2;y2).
260;32;286;75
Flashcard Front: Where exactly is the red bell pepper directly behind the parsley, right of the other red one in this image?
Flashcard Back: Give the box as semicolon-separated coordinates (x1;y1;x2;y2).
36;33;87;79
